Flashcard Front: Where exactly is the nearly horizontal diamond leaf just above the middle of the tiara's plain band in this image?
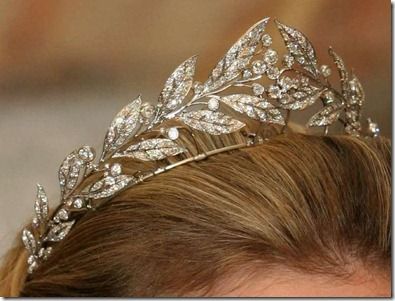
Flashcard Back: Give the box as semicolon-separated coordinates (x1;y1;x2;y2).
113;138;186;161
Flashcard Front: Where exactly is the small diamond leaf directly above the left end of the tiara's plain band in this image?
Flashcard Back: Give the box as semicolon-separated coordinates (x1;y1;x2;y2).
88;175;137;199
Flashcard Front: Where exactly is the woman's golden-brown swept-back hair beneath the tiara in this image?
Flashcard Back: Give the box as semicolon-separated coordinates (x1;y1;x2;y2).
0;129;391;297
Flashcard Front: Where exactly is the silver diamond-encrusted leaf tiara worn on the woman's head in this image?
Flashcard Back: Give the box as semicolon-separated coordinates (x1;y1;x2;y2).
22;18;379;273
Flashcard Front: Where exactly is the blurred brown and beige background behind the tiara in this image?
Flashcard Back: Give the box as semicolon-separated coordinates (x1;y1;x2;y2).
0;0;391;255
